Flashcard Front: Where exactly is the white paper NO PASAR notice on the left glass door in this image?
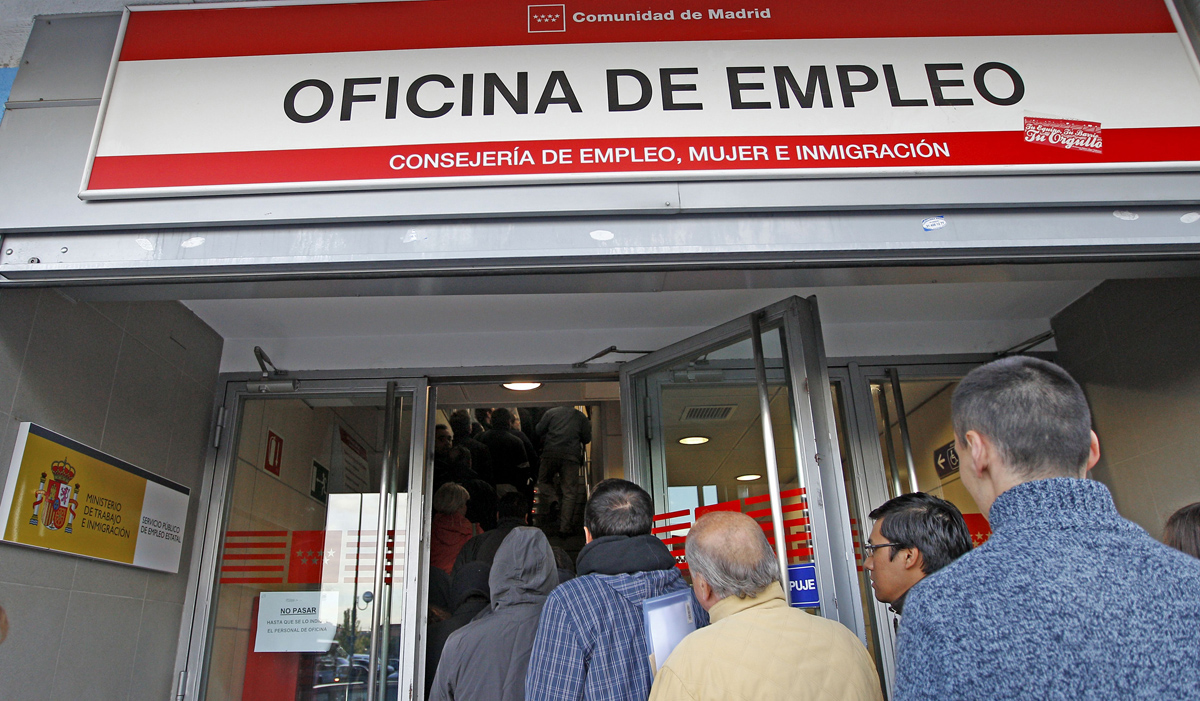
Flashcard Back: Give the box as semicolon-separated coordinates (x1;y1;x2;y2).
254;592;337;652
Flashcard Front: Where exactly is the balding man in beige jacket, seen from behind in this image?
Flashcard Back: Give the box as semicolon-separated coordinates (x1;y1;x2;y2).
650;511;883;701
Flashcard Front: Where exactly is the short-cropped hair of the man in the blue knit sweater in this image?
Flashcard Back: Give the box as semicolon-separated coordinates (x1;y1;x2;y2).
952;355;1092;479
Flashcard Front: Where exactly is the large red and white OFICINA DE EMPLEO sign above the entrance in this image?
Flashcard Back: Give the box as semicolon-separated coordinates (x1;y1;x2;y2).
80;0;1200;199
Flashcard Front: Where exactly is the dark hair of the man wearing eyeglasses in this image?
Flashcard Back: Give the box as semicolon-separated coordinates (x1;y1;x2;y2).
870;492;971;575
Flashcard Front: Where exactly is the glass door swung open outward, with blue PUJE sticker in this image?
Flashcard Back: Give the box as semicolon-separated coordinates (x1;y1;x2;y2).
620;298;865;642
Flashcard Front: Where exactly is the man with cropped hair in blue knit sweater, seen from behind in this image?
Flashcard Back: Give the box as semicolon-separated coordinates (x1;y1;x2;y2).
895;357;1200;700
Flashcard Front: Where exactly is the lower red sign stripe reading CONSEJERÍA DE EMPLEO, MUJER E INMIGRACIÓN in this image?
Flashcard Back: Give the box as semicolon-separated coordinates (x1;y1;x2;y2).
88;127;1200;193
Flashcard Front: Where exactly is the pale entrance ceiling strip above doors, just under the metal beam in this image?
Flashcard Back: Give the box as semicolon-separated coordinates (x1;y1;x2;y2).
184;281;1097;341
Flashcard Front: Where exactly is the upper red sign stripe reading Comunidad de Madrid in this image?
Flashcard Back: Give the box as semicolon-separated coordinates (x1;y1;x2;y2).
121;0;1175;61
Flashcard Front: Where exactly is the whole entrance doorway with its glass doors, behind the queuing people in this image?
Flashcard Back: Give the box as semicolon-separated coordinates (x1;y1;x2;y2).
177;298;1003;701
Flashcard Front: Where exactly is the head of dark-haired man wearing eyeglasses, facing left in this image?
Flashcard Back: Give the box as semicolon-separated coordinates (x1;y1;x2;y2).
863;492;971;625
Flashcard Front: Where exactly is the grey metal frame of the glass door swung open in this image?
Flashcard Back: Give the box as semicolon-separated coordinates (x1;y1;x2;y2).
620;296;866;642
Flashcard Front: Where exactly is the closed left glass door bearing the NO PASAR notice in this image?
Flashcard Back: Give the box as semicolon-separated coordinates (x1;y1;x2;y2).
185;381;426;701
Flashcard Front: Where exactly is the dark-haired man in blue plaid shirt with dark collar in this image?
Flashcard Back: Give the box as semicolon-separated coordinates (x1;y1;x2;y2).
526;479;708;701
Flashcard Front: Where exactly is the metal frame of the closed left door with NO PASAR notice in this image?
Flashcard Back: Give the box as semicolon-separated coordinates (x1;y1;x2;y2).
175;376;432;701
